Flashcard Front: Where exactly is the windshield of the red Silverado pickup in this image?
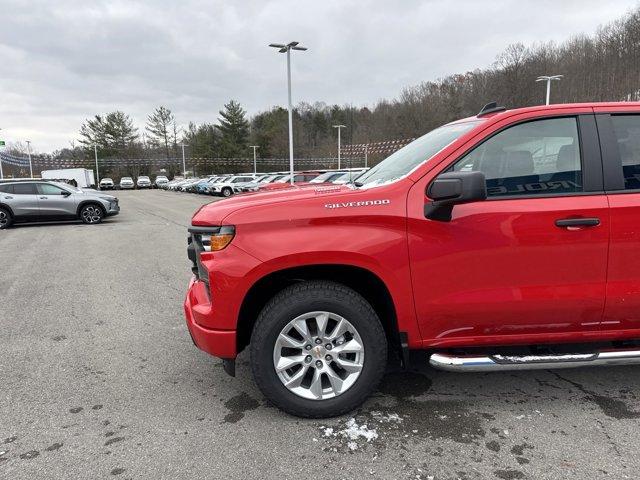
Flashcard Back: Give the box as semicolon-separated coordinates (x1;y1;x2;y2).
356;121;479;187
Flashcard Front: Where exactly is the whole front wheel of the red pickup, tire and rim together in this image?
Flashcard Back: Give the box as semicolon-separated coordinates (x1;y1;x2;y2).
251;281;387;418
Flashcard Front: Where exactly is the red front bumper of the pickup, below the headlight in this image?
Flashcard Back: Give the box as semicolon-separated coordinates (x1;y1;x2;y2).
184;277;237;359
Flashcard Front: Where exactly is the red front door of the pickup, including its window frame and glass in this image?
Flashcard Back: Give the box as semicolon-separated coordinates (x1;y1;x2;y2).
408;115;610;346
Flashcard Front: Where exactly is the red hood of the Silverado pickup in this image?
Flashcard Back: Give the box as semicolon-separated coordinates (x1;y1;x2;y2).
191;185;350;226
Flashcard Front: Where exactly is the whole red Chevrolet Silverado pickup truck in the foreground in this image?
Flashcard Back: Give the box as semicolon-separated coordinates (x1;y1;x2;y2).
184;103;640;417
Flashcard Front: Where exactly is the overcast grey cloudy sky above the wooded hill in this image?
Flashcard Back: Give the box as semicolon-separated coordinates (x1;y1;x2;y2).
0;0;639;152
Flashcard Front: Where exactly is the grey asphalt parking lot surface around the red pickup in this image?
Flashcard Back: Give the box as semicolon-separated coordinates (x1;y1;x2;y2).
0;190;640;480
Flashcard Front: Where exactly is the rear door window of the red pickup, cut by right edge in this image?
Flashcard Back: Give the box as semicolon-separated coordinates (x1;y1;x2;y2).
611;115;640;190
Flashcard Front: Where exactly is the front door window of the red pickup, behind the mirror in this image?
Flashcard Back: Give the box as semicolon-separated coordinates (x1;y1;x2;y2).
449;117;582;197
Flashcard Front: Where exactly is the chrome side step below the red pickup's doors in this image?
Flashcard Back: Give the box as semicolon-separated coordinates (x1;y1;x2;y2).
429;350;640;372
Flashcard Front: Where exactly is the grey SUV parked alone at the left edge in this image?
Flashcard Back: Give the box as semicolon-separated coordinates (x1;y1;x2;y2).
0;180;120;229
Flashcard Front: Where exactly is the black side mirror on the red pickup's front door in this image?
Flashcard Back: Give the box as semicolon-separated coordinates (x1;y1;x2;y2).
424;172;487;222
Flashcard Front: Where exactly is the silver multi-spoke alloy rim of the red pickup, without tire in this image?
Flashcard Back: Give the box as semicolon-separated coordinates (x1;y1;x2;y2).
273;311;364;400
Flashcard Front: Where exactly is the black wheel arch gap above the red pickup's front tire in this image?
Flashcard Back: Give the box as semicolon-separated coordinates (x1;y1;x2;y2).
236;264;400;352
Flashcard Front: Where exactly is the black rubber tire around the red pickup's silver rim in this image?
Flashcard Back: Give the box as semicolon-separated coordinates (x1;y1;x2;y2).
250;281;387;418
